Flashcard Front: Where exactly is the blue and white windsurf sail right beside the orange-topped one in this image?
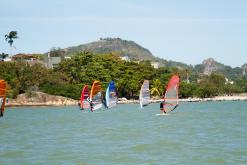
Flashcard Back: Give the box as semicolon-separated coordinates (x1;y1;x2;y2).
105;81;117;108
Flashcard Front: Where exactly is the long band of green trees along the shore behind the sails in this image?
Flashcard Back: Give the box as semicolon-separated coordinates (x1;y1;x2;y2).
0;51;247;99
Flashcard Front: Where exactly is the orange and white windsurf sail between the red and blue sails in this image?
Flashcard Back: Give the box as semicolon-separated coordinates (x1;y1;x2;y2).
90;81;102;111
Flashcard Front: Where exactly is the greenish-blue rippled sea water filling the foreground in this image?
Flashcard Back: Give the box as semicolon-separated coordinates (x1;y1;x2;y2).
0;101;247;165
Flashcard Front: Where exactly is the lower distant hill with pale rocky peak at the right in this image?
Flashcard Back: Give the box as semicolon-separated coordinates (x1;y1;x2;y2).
194;58;247;79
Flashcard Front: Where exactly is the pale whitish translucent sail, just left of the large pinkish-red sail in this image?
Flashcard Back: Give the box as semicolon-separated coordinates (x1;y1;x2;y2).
139;80;150;108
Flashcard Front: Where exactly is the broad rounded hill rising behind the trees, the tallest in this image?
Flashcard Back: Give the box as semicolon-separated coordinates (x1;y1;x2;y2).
60;38;189;68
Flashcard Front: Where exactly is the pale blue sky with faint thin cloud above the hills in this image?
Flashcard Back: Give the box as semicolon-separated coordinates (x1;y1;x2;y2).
0;0;247;67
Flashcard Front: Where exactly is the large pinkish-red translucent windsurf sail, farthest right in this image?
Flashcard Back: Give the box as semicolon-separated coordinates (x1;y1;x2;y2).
163;75;179;113
